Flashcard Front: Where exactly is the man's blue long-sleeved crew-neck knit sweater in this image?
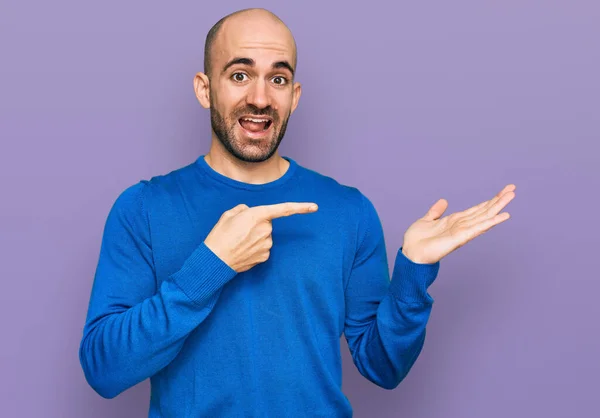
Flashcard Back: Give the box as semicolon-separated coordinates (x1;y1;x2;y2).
79;156;439;418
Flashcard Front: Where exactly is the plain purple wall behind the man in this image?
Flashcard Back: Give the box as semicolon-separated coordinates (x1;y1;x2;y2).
0;0;600;418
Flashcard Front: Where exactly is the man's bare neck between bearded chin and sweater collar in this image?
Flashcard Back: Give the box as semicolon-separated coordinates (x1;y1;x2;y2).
204;139;290;184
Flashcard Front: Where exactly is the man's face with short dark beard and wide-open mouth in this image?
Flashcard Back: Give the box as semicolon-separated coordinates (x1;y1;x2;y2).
202;17;300;162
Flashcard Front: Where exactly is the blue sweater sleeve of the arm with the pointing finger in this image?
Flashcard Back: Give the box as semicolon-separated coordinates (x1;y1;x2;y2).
79;182;236;398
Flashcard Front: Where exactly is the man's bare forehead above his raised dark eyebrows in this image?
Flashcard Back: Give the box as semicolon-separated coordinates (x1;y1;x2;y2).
213;19;295;67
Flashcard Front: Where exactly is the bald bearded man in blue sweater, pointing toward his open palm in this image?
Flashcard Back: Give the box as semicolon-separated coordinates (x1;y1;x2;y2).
80;9;514;417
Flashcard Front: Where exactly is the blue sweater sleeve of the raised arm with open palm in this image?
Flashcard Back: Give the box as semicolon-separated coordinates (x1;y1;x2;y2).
344;194;440;389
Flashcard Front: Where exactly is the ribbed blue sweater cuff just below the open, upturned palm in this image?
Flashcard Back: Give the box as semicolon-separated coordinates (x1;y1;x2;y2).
390;247;440;303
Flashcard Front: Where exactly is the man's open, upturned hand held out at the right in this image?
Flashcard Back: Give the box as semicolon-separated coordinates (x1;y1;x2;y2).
402;184;516;264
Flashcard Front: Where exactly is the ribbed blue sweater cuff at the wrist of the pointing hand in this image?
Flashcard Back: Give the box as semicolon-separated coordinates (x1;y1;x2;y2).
173;243;237;305
